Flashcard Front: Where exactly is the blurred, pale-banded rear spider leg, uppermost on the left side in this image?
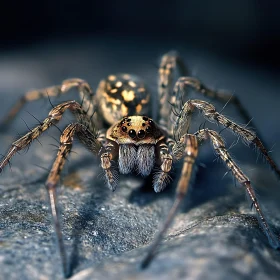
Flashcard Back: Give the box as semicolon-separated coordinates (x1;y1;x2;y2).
0;78;95;127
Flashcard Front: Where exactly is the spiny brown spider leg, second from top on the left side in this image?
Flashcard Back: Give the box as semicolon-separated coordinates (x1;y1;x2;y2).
0;101;100;173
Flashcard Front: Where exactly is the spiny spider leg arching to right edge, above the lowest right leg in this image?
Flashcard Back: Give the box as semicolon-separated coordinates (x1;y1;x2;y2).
174;99;280;178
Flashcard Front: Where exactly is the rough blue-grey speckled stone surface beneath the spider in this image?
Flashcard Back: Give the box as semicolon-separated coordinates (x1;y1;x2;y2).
0;38;280;280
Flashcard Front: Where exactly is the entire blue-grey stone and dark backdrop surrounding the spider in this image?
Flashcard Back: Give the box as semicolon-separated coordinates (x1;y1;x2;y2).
0;0;280;279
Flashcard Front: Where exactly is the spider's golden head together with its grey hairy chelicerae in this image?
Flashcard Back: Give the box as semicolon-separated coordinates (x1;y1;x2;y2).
106;116;169;180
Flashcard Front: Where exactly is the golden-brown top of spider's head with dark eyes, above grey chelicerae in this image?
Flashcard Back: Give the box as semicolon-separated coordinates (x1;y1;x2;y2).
106;116;165;146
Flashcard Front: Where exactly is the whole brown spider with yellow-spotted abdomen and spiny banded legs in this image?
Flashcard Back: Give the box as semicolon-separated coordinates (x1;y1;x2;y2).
0;51;280;277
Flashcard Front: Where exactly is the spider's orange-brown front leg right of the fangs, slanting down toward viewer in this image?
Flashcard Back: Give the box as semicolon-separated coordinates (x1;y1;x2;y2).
141;134;198;268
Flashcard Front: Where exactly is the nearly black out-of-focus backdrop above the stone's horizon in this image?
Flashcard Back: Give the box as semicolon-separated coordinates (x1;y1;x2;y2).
0;0;280;72
